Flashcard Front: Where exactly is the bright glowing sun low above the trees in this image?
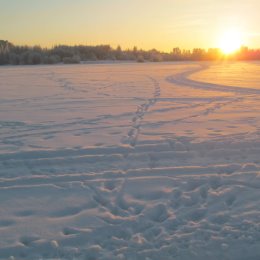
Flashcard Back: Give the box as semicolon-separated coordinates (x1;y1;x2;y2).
219;30;243;54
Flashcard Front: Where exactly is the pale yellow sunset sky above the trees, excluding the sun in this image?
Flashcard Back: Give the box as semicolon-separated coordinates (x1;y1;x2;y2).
0;0;260;51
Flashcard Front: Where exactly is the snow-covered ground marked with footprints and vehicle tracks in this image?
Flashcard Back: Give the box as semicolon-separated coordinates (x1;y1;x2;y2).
0;63;260;260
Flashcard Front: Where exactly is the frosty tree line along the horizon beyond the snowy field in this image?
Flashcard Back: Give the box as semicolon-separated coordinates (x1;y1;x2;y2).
0;40;260;65
